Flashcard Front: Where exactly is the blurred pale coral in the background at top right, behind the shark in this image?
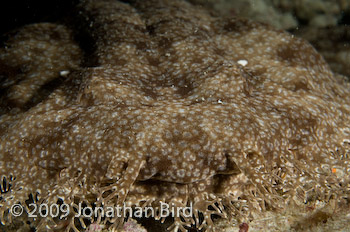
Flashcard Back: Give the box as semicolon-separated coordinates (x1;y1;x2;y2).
190;0;350;29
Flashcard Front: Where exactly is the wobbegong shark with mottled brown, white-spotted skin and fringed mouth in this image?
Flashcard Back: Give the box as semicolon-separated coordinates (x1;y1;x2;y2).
0;0;350;231
